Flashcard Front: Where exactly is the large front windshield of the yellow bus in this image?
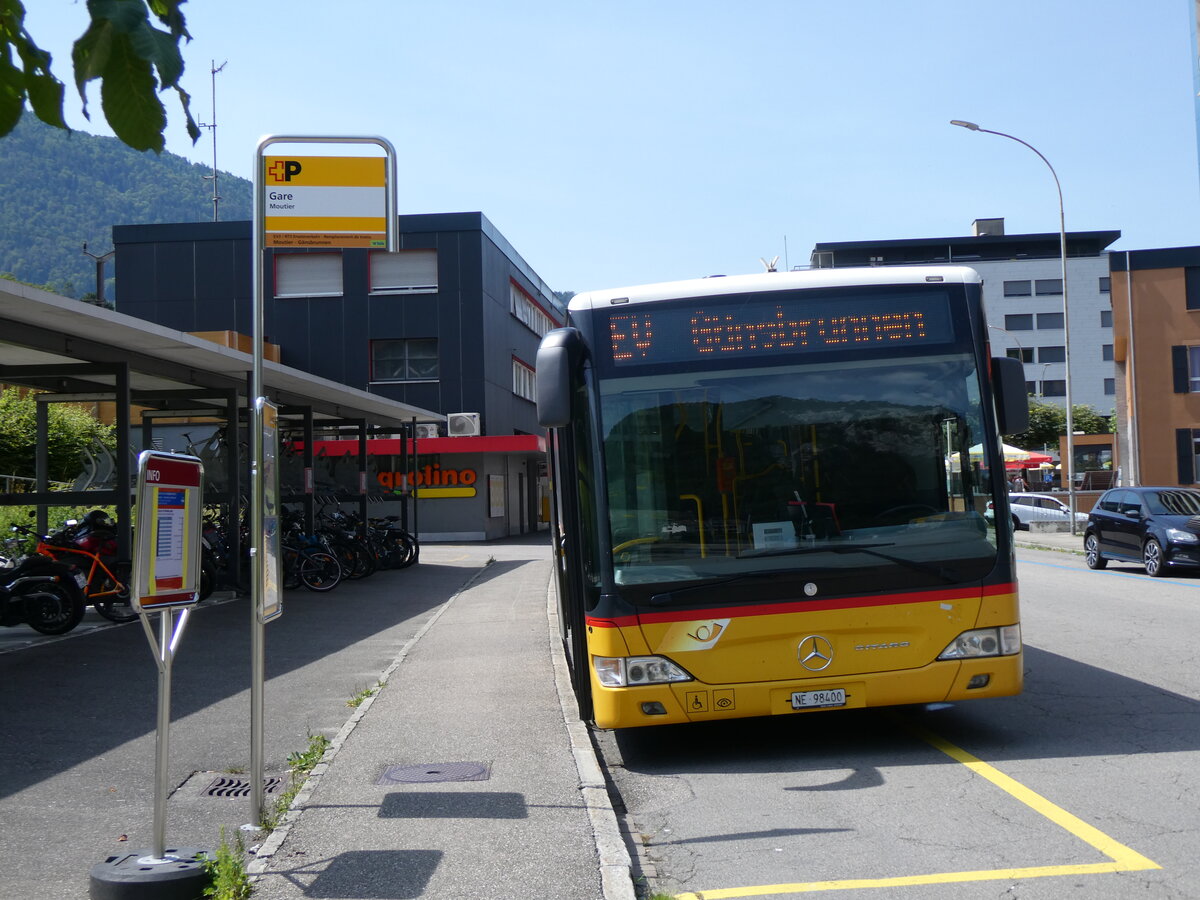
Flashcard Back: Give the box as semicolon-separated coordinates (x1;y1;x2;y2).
599;344;996;606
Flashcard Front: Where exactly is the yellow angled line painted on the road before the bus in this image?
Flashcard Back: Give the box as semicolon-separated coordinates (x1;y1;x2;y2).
676;725;1162;900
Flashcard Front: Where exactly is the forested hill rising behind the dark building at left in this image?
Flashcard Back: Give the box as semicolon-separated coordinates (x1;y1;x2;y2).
0;113;253;300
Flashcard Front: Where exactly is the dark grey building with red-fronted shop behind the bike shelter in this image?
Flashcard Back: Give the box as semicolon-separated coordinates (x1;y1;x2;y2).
113;212;564;539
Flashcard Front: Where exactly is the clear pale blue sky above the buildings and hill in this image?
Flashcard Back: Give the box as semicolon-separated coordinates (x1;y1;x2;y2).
26;0;1200;290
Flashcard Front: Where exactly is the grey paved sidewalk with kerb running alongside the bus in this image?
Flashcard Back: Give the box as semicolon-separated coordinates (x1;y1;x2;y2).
250;542;634;900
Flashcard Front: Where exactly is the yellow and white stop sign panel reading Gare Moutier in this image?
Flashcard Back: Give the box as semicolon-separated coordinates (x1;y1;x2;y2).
262;156;388;247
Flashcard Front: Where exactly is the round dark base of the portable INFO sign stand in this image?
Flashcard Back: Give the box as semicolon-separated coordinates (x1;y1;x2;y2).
88;847;212;900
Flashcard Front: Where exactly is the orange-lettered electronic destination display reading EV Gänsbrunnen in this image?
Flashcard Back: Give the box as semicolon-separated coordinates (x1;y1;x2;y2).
608;292;953;366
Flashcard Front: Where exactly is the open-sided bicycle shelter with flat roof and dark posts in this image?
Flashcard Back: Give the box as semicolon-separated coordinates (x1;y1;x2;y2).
0;281;443;580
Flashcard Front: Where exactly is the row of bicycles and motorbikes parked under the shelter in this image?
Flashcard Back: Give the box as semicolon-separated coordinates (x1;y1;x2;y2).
0;508;420;635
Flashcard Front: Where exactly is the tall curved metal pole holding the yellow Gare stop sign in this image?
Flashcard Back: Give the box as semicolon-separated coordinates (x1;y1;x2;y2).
250;134;400;824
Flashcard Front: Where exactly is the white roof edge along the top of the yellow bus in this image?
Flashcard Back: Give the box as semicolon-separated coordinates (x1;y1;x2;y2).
568;265;982;311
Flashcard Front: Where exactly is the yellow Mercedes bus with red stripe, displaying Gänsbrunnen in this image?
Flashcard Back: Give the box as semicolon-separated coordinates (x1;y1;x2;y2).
536;266;1028;728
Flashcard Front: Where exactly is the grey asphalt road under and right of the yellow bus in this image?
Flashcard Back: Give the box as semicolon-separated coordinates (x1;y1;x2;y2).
599;550;1200;900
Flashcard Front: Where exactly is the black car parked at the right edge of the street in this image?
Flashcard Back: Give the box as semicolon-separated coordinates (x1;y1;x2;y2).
1084;487;1200;577
